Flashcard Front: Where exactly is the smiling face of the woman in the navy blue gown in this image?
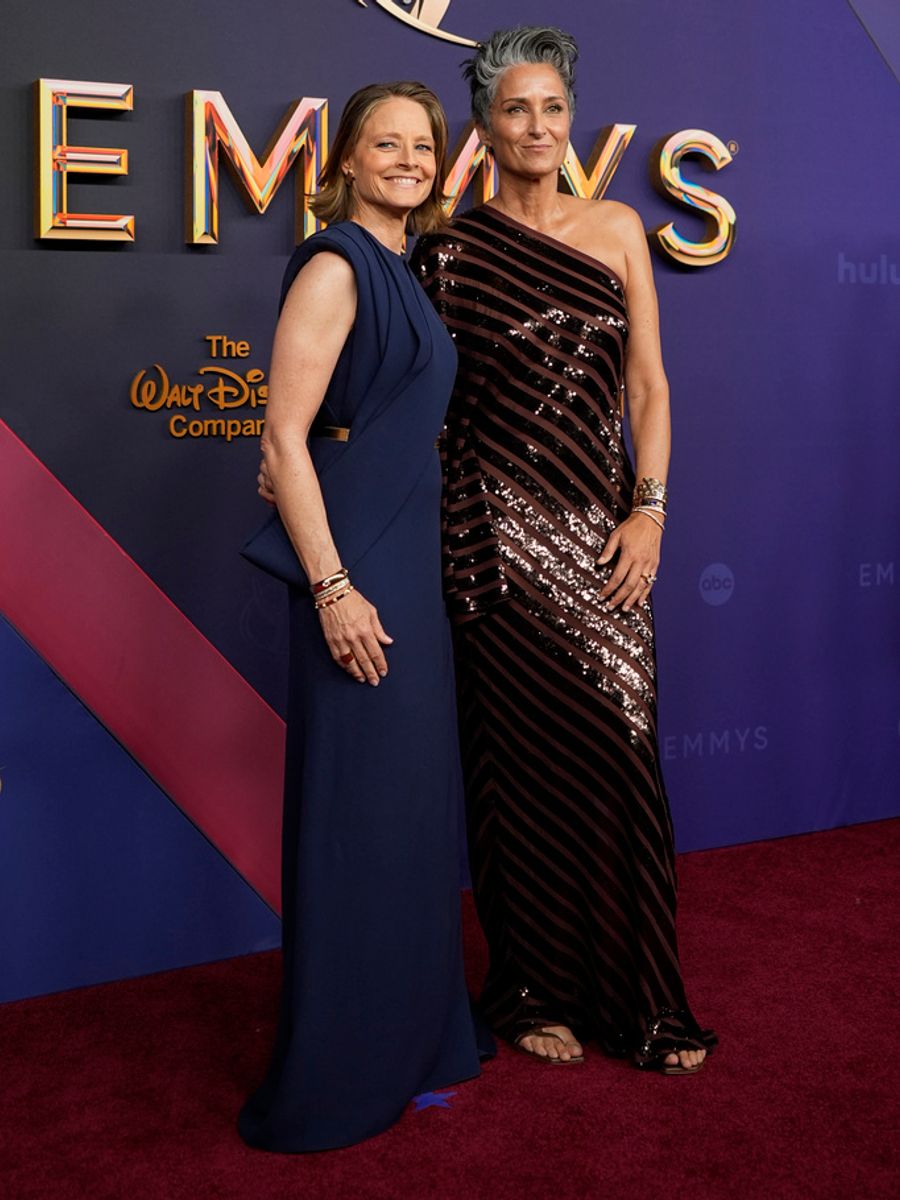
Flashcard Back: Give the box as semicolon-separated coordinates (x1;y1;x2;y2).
341;96;437;216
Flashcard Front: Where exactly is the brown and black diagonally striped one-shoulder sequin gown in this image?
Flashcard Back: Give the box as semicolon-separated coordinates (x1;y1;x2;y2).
413;208;714;1067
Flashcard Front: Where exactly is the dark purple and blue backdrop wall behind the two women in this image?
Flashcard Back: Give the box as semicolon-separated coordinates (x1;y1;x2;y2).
0;0;900;998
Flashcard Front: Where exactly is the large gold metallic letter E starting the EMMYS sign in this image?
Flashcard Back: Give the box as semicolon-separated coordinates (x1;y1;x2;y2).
35;79;134;241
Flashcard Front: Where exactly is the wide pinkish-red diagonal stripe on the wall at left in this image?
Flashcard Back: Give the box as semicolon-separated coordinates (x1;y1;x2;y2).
0;421;284;911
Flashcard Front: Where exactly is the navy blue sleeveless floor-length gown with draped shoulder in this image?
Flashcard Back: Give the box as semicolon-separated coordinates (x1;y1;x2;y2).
239;222;480;1151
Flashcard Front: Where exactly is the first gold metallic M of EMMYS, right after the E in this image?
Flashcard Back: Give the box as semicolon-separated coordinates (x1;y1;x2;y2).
185;91;328;246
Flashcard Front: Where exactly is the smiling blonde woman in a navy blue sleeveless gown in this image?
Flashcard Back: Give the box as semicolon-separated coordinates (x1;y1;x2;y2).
239;84;479;1152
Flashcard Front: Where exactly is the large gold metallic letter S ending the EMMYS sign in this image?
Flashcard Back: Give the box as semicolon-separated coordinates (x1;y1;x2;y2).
650;130;737;266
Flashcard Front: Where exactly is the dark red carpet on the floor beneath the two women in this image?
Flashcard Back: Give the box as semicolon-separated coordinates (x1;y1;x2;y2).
0;821;900;1200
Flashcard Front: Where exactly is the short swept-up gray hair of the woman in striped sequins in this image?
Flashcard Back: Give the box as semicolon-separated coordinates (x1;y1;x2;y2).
463;25;578;128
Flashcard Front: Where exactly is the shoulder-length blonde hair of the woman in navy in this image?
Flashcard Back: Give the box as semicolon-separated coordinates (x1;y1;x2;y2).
310;79;448;234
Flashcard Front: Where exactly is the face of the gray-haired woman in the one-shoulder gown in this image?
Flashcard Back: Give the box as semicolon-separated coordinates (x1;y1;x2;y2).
479;62;571;179
